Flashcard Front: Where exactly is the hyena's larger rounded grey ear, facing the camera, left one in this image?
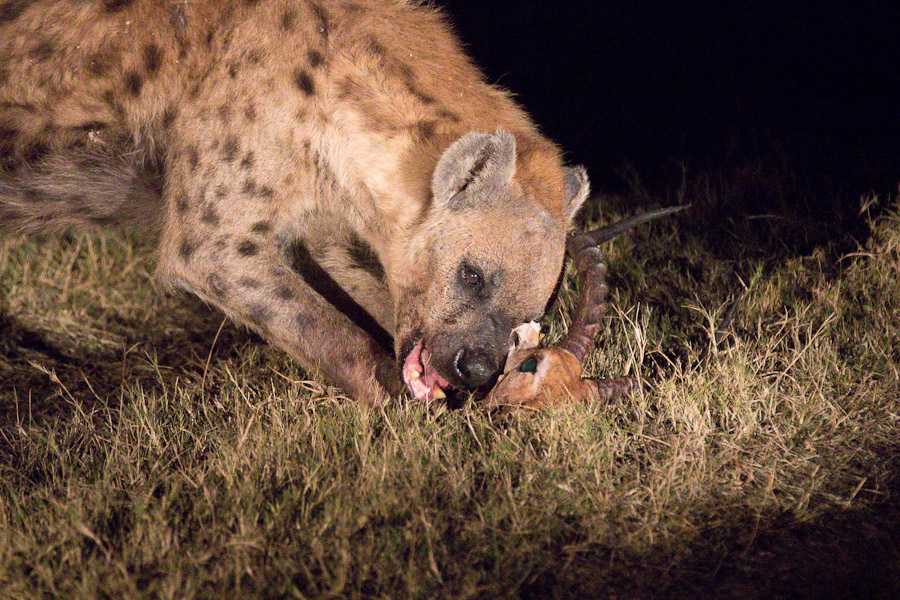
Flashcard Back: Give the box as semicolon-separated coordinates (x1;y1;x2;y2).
431;129;516;209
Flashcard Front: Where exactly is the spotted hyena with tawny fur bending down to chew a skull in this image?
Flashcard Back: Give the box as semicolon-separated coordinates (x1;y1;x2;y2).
0;0;588;402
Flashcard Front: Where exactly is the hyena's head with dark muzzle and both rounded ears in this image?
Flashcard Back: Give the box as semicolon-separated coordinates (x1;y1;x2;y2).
394;129;588;400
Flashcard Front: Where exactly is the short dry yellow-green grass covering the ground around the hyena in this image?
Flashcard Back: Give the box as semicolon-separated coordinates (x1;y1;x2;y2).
0;176;900;598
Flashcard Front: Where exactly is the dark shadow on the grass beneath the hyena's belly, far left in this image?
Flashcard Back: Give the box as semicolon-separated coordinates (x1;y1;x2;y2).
0;298;261;427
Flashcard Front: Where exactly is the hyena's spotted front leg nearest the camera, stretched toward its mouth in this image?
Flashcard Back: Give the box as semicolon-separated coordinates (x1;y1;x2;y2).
159;188;403;403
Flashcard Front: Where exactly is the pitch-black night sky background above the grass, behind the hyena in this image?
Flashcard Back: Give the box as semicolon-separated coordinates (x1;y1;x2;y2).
440;0;900;203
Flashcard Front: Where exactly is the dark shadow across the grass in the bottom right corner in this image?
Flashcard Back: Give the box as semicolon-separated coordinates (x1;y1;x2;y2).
520;482;900;600
